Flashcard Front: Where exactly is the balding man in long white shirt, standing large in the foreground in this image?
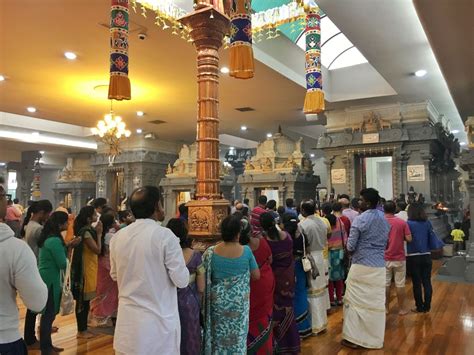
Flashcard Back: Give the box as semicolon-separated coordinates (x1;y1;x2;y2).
110;186;189;355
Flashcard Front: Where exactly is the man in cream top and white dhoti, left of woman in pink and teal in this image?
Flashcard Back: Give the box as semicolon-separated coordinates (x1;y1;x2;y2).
299;200;329;334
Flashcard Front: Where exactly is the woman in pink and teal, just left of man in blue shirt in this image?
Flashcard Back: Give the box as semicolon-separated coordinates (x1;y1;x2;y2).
326;213;347;307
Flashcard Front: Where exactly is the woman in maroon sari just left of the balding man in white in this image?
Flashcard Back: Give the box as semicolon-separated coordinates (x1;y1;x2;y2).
91;214;118;327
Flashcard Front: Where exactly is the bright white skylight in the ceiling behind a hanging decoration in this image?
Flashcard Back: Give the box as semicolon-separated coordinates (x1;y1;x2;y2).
296;16;367;70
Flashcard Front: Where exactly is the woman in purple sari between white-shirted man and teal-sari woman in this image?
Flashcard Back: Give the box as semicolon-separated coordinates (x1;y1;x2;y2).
166;218;206;355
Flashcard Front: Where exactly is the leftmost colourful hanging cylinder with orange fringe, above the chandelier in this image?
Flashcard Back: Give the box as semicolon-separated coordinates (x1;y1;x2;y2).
109;0;131;100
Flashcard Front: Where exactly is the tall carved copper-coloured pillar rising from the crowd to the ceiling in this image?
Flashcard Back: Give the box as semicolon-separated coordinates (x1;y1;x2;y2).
180;4;230;250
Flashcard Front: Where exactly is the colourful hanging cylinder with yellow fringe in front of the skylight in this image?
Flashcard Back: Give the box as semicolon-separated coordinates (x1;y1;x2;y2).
303;7;324;114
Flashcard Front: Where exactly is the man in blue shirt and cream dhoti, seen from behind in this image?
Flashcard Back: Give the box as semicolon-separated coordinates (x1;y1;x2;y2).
342;188;390;349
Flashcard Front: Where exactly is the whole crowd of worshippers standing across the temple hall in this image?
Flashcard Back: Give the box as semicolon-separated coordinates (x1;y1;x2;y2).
0;179;452;354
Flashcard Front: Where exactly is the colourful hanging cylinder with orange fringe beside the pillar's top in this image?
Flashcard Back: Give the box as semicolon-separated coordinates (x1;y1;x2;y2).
229;0;254;79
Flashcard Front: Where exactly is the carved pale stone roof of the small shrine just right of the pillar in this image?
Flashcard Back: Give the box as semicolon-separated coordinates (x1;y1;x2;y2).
244;130;313;174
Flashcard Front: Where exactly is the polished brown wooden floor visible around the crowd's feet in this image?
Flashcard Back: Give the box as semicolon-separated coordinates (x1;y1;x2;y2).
19;261;474;355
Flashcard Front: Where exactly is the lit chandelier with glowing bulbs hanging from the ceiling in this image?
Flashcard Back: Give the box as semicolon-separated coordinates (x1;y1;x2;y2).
92;111;132;166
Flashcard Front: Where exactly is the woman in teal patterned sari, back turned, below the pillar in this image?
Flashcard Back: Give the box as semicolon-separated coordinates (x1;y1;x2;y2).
203;216;260;355
